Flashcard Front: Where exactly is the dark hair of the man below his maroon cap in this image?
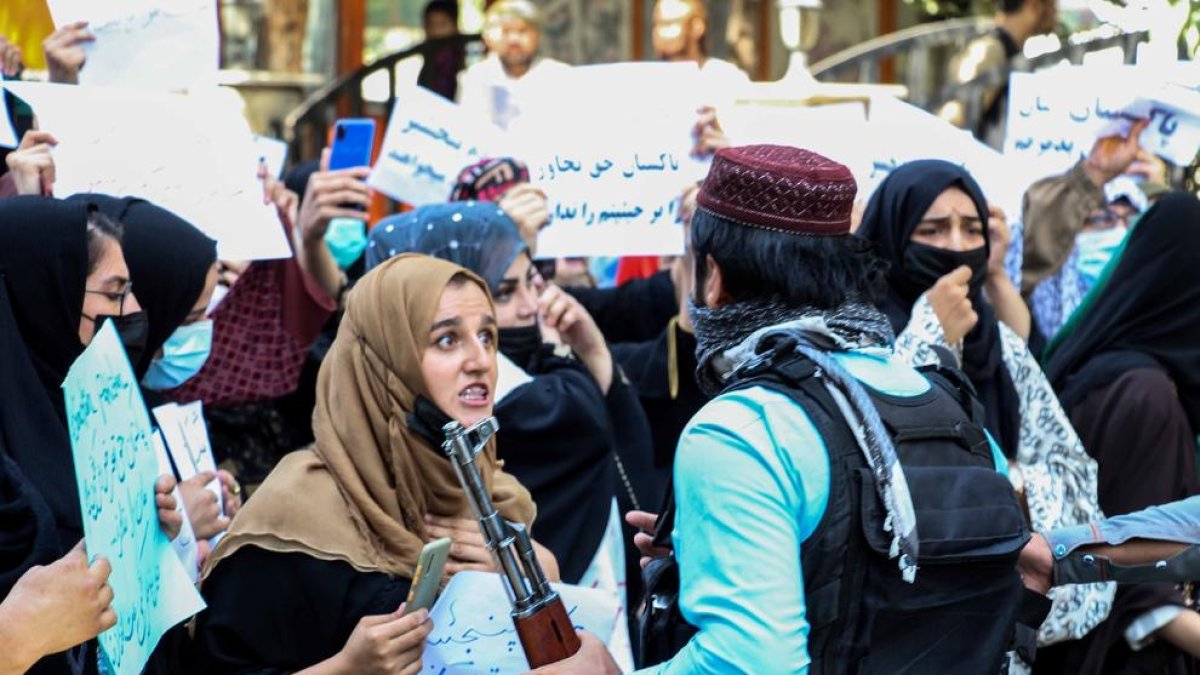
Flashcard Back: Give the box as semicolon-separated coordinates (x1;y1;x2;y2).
691;208;887;310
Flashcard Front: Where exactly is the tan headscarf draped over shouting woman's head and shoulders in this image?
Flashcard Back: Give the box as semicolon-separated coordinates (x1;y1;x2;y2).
204;255;534;577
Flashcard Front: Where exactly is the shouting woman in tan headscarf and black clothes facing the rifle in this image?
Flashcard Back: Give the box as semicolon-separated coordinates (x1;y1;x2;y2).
196;256;534;674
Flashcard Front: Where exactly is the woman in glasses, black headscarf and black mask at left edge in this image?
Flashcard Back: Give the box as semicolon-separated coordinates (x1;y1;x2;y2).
0;197;181;674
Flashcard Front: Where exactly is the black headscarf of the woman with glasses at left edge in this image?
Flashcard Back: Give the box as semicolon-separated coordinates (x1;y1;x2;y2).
0;197;88;546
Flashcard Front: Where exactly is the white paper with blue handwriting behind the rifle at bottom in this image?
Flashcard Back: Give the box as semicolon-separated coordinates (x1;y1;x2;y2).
422;572;625;675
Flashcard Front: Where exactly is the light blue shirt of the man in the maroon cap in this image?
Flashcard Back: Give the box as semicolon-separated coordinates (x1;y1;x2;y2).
640;351;1007;675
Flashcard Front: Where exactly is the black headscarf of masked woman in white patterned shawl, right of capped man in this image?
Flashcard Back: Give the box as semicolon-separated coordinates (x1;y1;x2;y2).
857;160;1021;458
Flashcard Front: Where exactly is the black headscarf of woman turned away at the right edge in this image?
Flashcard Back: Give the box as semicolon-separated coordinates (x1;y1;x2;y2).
1045;192;1200;432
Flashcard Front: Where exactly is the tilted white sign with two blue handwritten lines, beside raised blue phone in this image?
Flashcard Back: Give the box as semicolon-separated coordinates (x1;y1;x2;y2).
367;86;502;205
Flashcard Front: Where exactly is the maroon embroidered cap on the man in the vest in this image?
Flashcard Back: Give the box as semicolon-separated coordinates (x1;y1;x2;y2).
696;145;857;234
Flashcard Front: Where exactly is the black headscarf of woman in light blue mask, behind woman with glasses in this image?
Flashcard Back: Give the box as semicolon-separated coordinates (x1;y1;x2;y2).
68;195;217;380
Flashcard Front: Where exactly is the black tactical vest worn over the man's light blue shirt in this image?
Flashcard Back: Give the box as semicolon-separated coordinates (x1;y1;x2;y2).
641;345;1028;675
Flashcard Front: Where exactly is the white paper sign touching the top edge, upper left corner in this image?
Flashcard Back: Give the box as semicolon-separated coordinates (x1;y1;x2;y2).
48;0;221;90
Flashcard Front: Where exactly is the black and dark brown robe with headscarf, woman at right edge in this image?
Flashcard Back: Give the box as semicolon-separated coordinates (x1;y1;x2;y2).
1038;193;1200;675
